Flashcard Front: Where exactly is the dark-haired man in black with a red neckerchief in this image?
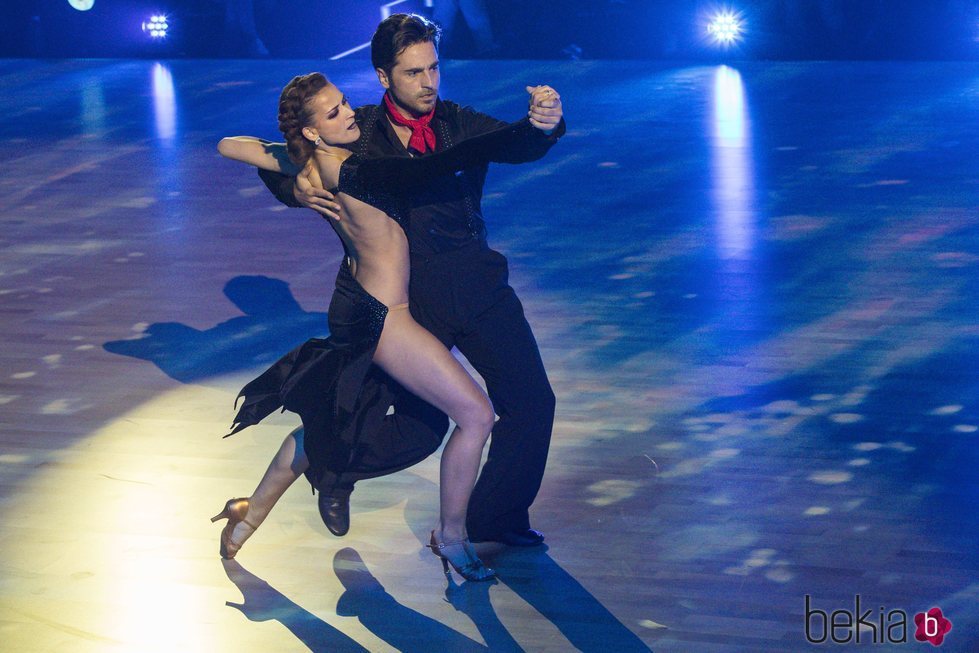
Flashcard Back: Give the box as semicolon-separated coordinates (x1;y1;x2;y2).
260;14;565;546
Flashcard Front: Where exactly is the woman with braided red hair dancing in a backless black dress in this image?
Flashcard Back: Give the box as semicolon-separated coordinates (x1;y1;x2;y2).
214;73;533;580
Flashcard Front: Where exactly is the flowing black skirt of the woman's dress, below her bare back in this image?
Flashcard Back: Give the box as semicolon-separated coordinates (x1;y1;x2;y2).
229;260;448;491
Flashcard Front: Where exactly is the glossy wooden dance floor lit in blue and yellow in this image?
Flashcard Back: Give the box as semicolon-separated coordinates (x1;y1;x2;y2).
0;60;979;653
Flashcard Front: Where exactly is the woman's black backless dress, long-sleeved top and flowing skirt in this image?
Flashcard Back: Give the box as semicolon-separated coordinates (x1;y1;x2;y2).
229;121;533;491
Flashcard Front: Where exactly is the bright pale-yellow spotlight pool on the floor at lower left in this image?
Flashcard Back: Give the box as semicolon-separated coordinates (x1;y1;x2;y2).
0;385;482;651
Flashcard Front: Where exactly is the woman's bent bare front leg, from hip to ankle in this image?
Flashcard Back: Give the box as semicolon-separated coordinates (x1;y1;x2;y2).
374;309;495;542
